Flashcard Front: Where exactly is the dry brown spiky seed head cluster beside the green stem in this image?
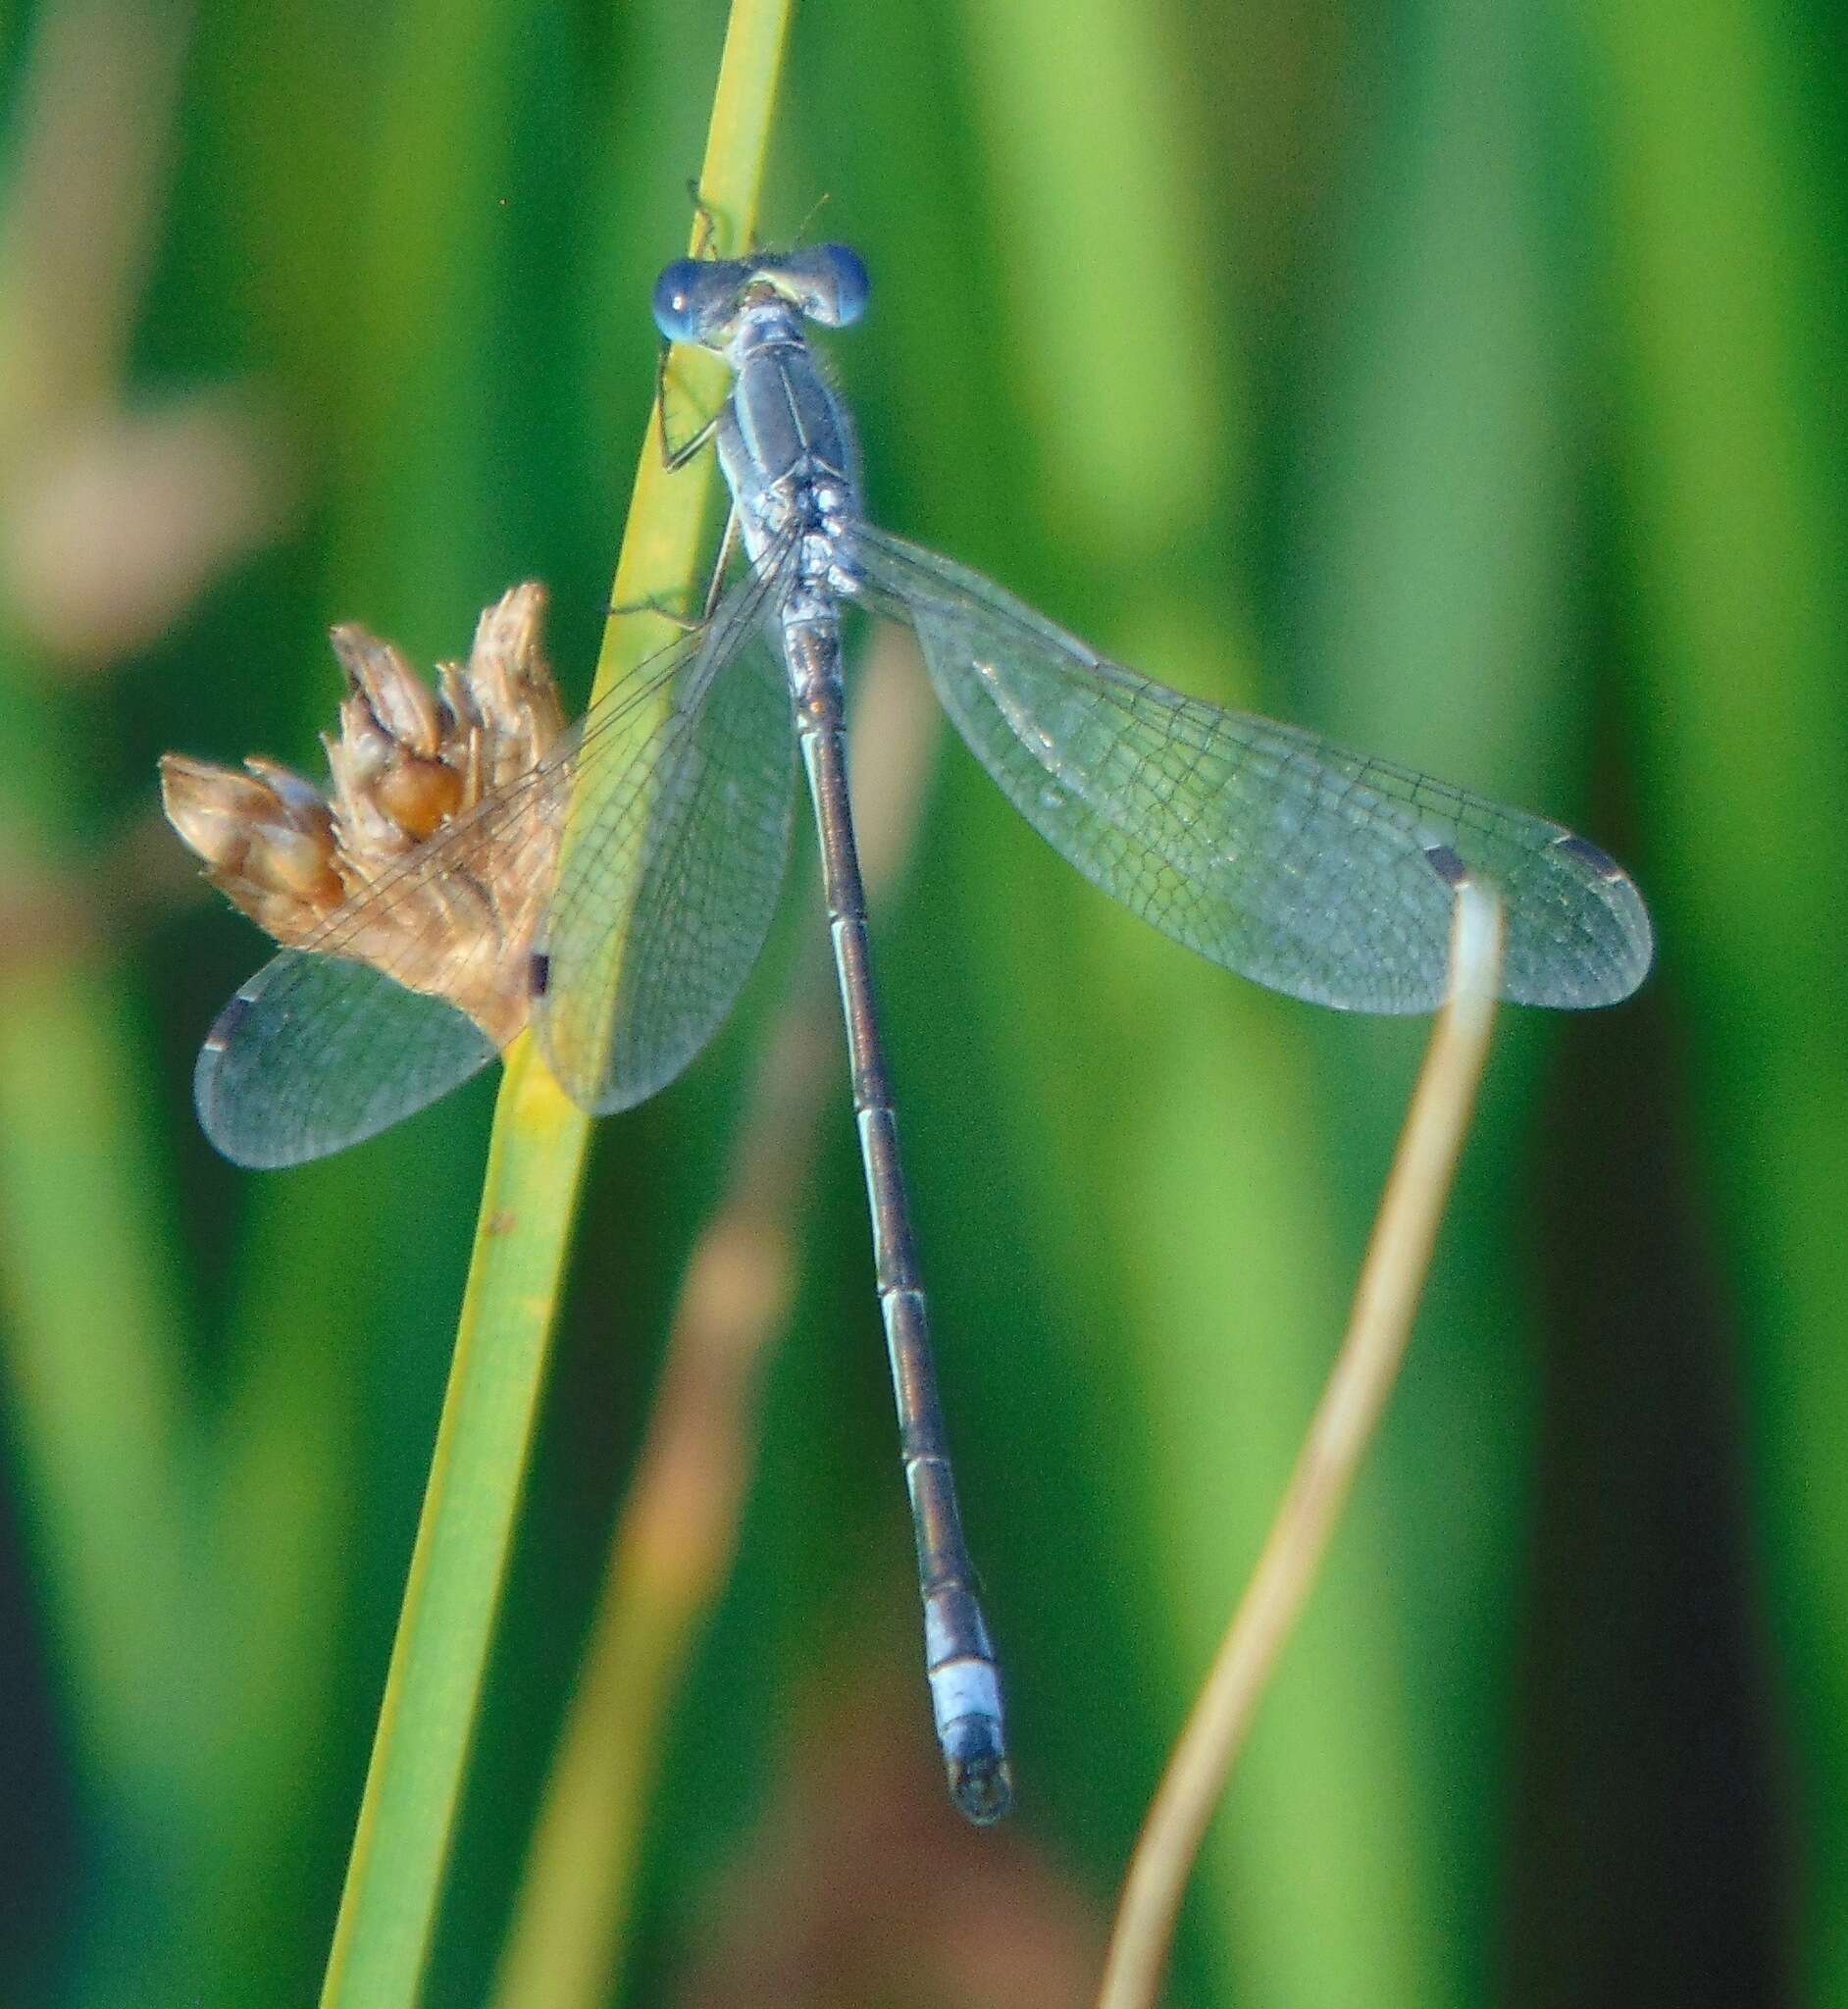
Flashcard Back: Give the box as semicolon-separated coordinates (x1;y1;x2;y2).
161;583;564;1045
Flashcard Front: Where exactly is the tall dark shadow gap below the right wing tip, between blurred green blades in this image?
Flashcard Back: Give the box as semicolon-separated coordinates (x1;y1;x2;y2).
1503;958;1798;2009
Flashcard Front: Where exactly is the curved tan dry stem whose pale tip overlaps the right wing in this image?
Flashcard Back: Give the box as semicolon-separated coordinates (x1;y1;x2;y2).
1099;886;1503;2009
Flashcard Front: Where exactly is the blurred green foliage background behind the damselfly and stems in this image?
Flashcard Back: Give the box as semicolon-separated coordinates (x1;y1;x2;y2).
0;0;1848;2009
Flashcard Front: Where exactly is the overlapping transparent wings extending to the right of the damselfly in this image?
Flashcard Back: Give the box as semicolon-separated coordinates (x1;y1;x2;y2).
853;527;1651;1012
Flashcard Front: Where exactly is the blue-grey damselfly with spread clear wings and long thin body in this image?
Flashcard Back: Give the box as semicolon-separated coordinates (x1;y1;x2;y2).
173;245;1651;1820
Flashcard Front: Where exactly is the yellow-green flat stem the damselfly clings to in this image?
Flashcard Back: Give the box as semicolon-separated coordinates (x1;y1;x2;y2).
322;0;788;2009
